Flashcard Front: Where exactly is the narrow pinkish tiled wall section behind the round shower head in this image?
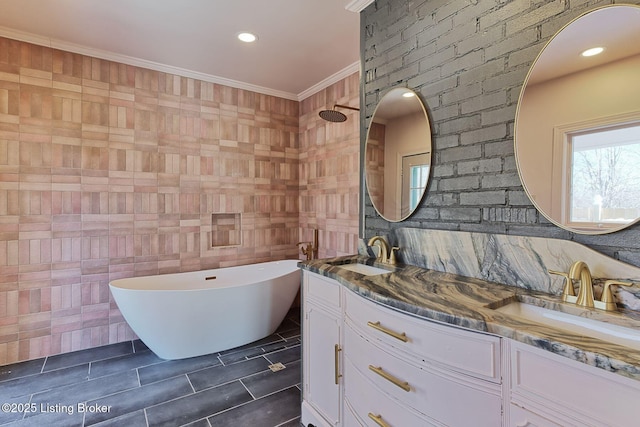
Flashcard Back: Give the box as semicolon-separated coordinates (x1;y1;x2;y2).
300;73;360;258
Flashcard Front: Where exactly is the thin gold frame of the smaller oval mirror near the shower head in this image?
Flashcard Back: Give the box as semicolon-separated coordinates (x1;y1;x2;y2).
363;86;433;222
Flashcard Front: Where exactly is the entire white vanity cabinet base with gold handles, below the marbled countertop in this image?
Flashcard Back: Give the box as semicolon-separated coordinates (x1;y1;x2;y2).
302;270;640;427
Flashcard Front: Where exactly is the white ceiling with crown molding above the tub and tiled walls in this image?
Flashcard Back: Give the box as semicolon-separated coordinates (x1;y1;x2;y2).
0;0;372;100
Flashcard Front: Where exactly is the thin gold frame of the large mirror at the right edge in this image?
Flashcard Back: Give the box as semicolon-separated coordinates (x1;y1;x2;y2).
514;4;640;235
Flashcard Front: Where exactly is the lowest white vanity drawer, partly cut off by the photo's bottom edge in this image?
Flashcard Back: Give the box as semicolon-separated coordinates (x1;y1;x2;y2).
344;358;438;427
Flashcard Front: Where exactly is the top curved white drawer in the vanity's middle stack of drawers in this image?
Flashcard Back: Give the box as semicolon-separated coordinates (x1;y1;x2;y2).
345;291;500;383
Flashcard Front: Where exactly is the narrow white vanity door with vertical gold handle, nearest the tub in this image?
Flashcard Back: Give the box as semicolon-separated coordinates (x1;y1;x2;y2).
302;271;342;427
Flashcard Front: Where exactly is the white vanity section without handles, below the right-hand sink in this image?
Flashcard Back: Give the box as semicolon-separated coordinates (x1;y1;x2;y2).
505;340;640;427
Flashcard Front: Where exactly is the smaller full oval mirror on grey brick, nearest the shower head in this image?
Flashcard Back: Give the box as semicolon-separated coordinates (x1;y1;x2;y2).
365;88;431;222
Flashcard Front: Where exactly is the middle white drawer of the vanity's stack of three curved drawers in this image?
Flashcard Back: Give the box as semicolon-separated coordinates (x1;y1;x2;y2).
343;326;502;427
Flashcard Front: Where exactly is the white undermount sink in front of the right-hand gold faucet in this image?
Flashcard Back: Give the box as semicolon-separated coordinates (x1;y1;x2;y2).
494;301;640;350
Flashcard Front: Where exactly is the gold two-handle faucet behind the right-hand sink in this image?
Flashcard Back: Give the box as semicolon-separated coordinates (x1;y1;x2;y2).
549;261;633;311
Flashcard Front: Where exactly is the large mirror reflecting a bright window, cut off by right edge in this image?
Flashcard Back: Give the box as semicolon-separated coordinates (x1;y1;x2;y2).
515;5;640;234
